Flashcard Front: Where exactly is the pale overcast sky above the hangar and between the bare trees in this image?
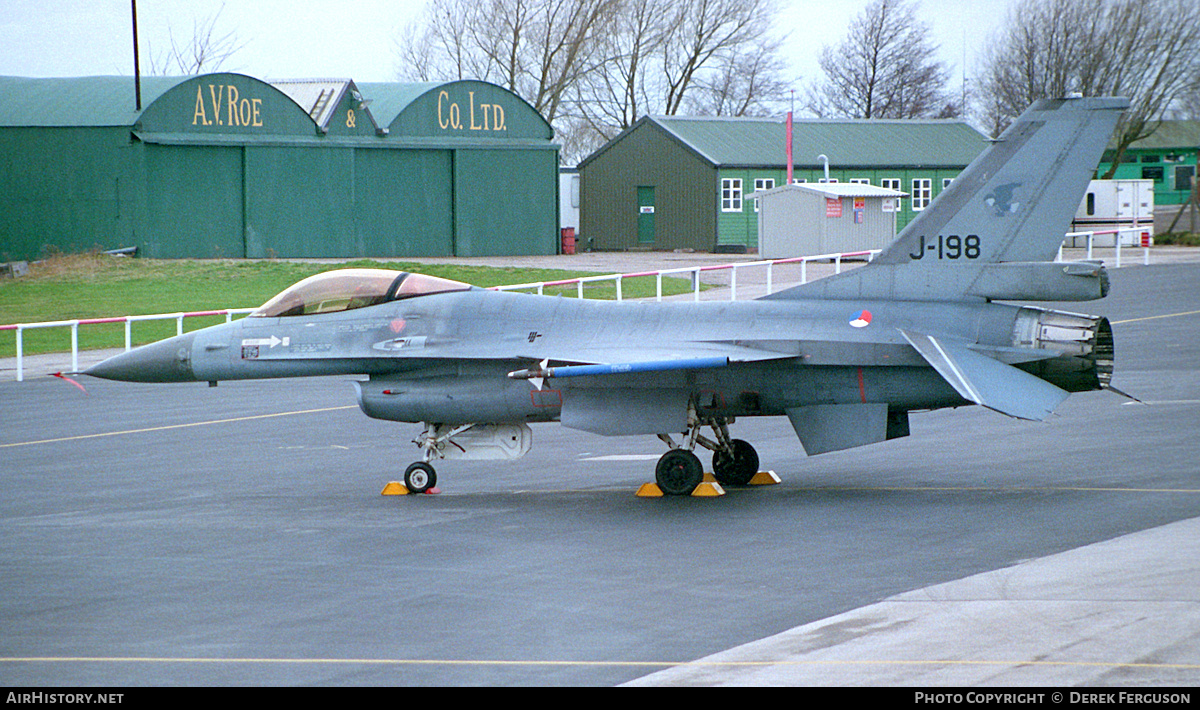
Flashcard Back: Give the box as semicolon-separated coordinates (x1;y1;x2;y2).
0;0;1014;102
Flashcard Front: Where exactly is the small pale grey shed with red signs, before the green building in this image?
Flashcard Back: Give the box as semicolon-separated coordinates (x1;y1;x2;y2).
750;182;907;259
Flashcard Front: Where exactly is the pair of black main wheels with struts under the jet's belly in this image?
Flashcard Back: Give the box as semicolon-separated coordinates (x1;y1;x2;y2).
654;411;758;495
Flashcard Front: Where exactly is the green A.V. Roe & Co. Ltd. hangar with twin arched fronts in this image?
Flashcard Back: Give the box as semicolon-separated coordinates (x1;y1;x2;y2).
0;73;558;260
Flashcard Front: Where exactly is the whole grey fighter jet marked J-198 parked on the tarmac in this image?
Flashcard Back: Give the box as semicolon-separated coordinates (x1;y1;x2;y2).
86;98;1128;494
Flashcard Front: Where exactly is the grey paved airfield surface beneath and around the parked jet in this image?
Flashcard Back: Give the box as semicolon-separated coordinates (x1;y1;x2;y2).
0;257;1200;686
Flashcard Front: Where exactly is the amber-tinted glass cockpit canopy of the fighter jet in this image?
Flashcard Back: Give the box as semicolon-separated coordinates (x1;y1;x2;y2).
250;269;470;318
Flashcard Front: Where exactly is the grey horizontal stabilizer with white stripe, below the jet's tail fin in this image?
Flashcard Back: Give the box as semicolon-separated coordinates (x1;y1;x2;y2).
900;330;1067;421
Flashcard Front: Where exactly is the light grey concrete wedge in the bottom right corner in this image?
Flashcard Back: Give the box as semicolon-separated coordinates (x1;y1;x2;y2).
626;518;1200;688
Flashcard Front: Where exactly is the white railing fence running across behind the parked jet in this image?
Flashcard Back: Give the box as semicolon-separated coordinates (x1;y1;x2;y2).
0;227;1150;381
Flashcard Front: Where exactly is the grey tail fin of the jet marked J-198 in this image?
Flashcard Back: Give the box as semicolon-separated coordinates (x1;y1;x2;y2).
774;98;1129;300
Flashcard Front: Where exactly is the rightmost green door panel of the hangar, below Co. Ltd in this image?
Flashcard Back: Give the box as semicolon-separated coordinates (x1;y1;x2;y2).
454;150;558;257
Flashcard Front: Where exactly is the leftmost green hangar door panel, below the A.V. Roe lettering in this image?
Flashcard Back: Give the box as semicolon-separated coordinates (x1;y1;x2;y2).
137;144;246;259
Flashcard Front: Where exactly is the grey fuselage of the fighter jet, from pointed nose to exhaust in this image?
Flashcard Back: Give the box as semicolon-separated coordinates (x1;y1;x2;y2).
90;289;1113;422
